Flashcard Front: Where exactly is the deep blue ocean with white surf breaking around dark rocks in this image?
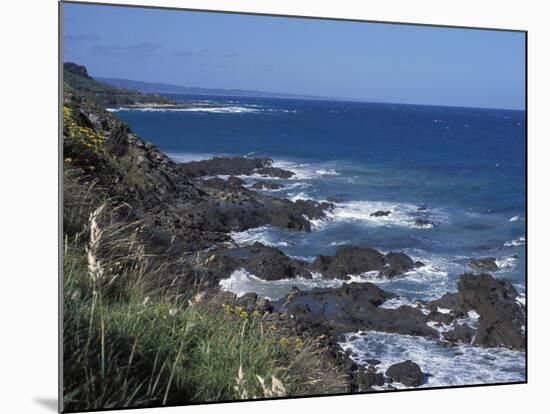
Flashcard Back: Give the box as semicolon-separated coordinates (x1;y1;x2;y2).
112;95;526;386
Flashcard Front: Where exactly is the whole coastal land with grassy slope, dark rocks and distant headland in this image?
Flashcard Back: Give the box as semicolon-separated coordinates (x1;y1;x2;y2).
63;64;525;409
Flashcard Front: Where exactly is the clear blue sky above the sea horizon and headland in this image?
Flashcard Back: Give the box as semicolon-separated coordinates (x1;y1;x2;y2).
63;3;525;109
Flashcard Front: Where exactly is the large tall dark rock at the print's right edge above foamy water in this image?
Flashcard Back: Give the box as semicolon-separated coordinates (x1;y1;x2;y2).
458;274;525;351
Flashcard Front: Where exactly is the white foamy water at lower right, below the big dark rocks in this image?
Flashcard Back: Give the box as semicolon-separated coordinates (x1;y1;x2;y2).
340;332;525;388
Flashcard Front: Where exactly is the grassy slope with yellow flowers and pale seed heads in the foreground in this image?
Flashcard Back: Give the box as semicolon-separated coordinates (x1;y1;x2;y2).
63;67;345;411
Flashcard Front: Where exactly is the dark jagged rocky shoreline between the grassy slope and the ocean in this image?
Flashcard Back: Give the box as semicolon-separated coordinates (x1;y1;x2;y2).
65;65;526;391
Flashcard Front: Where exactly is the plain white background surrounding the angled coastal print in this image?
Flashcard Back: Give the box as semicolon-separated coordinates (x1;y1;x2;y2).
0;0;550;414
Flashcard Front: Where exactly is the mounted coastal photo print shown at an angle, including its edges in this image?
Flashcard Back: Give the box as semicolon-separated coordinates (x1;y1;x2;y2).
60;2;527;412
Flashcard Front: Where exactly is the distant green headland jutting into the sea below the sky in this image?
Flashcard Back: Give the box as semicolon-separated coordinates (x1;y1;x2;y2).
63;62;175;107
